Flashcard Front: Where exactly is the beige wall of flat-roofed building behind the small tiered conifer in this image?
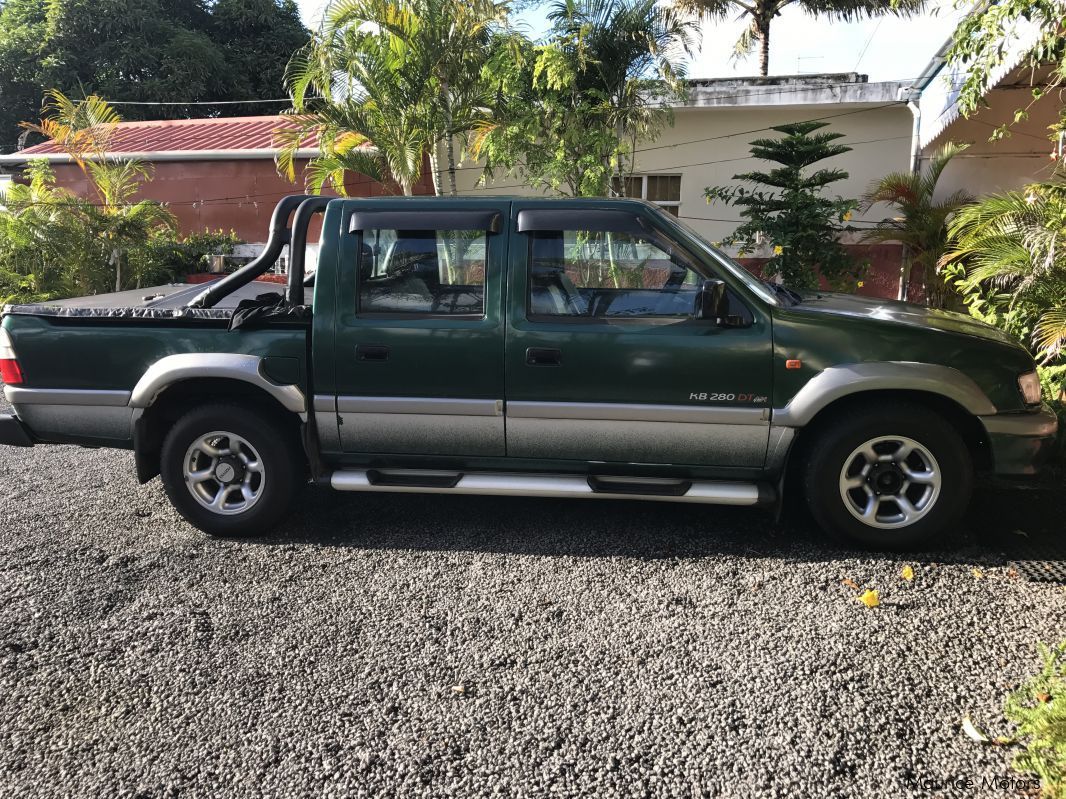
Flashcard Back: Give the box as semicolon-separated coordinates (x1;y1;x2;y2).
445;103;912;250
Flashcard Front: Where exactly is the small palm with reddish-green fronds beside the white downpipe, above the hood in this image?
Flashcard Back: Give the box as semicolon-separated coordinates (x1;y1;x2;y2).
862;143;972;308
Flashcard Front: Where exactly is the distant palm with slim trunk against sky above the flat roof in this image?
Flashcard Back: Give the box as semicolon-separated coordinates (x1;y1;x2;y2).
674;0;925;77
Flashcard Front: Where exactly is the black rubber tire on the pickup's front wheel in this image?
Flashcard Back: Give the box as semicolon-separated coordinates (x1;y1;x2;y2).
802;402;973;551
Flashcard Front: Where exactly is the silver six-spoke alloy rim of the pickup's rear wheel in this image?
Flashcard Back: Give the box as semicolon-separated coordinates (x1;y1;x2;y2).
182;430;267;516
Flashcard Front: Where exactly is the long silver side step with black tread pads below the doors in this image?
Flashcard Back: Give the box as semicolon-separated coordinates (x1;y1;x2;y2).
329;469;774;505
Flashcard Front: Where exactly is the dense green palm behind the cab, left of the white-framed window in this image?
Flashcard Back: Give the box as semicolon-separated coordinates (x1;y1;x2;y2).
472;0;695;197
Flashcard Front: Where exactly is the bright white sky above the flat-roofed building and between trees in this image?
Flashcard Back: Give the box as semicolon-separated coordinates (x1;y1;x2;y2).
297;0;962;81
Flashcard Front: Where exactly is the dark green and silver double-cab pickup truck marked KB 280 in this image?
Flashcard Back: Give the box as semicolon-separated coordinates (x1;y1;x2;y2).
0;196;1056;548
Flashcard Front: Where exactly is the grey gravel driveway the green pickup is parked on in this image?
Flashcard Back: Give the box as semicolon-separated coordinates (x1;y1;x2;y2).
0;396;1066;797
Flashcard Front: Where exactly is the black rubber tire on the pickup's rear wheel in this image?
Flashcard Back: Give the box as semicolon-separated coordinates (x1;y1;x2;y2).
160;403;304;536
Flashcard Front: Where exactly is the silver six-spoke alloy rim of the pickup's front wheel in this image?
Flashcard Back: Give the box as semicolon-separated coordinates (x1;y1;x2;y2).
839;436;941;529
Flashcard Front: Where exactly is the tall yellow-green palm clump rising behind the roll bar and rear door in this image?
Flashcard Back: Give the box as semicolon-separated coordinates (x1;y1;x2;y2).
278;0;507;194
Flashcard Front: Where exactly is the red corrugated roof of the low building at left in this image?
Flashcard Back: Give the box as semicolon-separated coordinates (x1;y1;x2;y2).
18;116;318;158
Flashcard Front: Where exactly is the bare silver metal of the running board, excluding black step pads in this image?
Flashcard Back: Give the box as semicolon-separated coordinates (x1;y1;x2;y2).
329;469;760;506
